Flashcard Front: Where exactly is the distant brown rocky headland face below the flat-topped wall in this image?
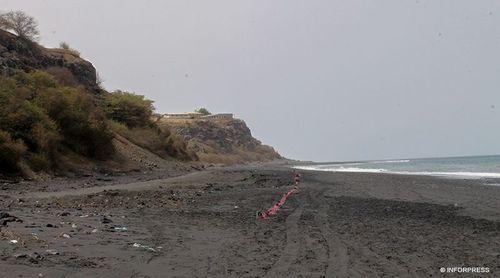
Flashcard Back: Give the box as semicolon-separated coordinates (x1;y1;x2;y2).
160;119;281;164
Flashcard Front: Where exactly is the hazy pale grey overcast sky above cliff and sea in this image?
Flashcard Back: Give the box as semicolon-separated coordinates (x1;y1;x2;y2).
0;0;500;161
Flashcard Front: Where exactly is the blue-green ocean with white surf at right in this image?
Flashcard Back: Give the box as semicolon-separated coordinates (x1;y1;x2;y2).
294;155;500;179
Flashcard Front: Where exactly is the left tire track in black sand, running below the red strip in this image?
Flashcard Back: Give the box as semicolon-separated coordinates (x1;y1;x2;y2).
264;205;304;278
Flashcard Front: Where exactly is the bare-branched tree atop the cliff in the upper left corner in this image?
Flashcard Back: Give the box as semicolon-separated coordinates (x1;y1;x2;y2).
0;11;40;41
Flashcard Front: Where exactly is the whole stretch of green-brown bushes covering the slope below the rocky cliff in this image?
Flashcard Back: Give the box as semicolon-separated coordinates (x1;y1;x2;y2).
0;71;193;175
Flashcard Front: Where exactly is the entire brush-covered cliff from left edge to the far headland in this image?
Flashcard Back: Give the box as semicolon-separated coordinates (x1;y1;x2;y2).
0;30;280;177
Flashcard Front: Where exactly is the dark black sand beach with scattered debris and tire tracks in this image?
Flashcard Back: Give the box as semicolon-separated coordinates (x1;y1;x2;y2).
0;166;500;277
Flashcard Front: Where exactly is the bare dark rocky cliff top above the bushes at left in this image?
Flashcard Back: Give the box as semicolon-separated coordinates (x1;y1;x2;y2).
0;30;99;92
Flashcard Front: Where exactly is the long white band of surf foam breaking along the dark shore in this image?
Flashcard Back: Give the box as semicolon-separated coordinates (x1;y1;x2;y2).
293;166;500;179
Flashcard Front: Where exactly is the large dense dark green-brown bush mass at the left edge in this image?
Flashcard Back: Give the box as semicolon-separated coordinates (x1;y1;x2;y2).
0;71;113;171
